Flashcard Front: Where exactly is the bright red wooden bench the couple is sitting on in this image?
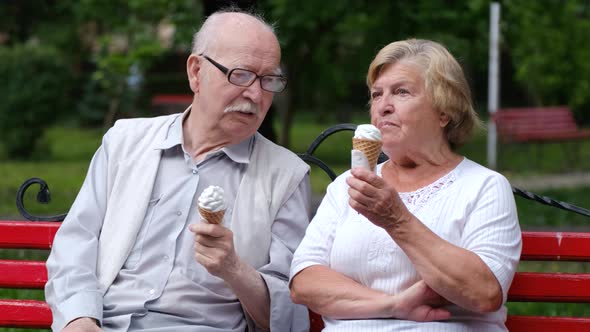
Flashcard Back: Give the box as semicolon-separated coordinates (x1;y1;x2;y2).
0;221;590;332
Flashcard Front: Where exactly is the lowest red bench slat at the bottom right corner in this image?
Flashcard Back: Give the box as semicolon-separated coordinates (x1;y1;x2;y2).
506;316;590;332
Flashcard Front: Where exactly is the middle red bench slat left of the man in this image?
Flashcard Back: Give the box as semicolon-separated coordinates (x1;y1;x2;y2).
0;259;47;289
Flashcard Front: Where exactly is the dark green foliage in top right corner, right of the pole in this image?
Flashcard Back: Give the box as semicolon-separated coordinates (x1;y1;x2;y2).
502;1;590;123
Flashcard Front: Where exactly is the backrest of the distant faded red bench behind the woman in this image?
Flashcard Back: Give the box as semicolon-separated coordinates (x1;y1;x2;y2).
493;106;578;141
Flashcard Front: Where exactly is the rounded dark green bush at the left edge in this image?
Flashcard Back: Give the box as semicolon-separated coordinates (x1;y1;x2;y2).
0;45;73;159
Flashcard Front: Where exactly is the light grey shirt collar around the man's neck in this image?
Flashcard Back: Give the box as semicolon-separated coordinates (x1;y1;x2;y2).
155;106;256;164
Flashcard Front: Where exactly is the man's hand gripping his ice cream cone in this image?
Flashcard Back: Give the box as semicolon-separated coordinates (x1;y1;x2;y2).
189;222;240;280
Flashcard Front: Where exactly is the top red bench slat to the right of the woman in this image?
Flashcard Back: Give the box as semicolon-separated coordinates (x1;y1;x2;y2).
521;232;590;262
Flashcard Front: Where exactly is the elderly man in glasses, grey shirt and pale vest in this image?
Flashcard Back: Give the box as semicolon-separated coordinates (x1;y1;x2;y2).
45;12;310;331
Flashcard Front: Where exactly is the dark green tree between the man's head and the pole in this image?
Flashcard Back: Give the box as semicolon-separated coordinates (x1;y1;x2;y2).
261;0;489;145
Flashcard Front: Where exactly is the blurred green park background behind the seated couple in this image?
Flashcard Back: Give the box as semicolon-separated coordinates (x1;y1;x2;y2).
0;0;590;326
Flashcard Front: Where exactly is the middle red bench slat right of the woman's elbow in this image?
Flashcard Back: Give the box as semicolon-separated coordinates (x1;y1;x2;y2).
508;272;590;303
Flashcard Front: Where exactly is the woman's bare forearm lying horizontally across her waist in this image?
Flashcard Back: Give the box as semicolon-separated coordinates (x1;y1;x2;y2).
291;265;395;319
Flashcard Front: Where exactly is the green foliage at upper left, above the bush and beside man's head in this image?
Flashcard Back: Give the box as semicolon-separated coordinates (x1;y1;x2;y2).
0;0;202;131
